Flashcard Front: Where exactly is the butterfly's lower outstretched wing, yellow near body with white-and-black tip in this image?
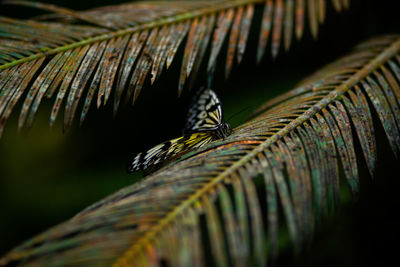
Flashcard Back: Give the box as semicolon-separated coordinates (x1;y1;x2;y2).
127;132;213;173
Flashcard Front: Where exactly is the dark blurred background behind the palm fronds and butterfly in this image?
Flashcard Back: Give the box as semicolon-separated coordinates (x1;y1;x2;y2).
0;0;400;266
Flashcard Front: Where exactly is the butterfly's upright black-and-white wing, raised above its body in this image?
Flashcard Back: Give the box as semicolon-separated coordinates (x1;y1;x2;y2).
183;89;222;134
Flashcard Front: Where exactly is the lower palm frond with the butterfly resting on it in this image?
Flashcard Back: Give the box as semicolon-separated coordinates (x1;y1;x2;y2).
0;36;400;266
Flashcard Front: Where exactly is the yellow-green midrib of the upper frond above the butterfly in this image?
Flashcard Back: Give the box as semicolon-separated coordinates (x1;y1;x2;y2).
0;0;264;71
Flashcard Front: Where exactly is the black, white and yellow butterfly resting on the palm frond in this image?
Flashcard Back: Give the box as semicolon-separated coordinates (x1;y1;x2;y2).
127;89;232;173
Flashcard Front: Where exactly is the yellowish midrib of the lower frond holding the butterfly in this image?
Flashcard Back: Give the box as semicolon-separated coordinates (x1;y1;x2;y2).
115;35;400;266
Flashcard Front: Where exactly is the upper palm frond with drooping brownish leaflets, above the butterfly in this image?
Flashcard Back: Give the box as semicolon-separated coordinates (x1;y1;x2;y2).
0;0;348;136
